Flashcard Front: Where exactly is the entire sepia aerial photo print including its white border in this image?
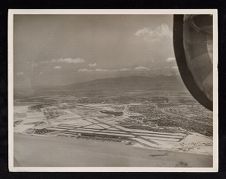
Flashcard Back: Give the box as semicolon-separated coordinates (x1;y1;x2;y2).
8;9;218;172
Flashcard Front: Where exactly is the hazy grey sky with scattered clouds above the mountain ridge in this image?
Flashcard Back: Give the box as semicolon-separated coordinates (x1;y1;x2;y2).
14;15;177;88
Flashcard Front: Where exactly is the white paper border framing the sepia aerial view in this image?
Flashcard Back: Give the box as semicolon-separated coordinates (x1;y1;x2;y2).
8;9;218;172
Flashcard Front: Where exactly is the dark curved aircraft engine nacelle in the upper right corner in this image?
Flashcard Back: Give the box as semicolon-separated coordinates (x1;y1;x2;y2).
173;15;213;110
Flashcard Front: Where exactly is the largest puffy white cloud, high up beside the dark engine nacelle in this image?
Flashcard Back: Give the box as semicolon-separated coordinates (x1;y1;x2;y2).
135;24;173;41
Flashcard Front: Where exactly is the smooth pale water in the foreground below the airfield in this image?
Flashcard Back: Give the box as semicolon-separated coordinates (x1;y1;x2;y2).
14;133;213;167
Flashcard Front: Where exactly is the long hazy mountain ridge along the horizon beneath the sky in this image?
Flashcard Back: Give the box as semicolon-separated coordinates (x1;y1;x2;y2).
15;75;186;98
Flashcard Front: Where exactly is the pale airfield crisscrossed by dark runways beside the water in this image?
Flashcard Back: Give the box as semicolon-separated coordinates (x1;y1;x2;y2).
15;104;187;148
